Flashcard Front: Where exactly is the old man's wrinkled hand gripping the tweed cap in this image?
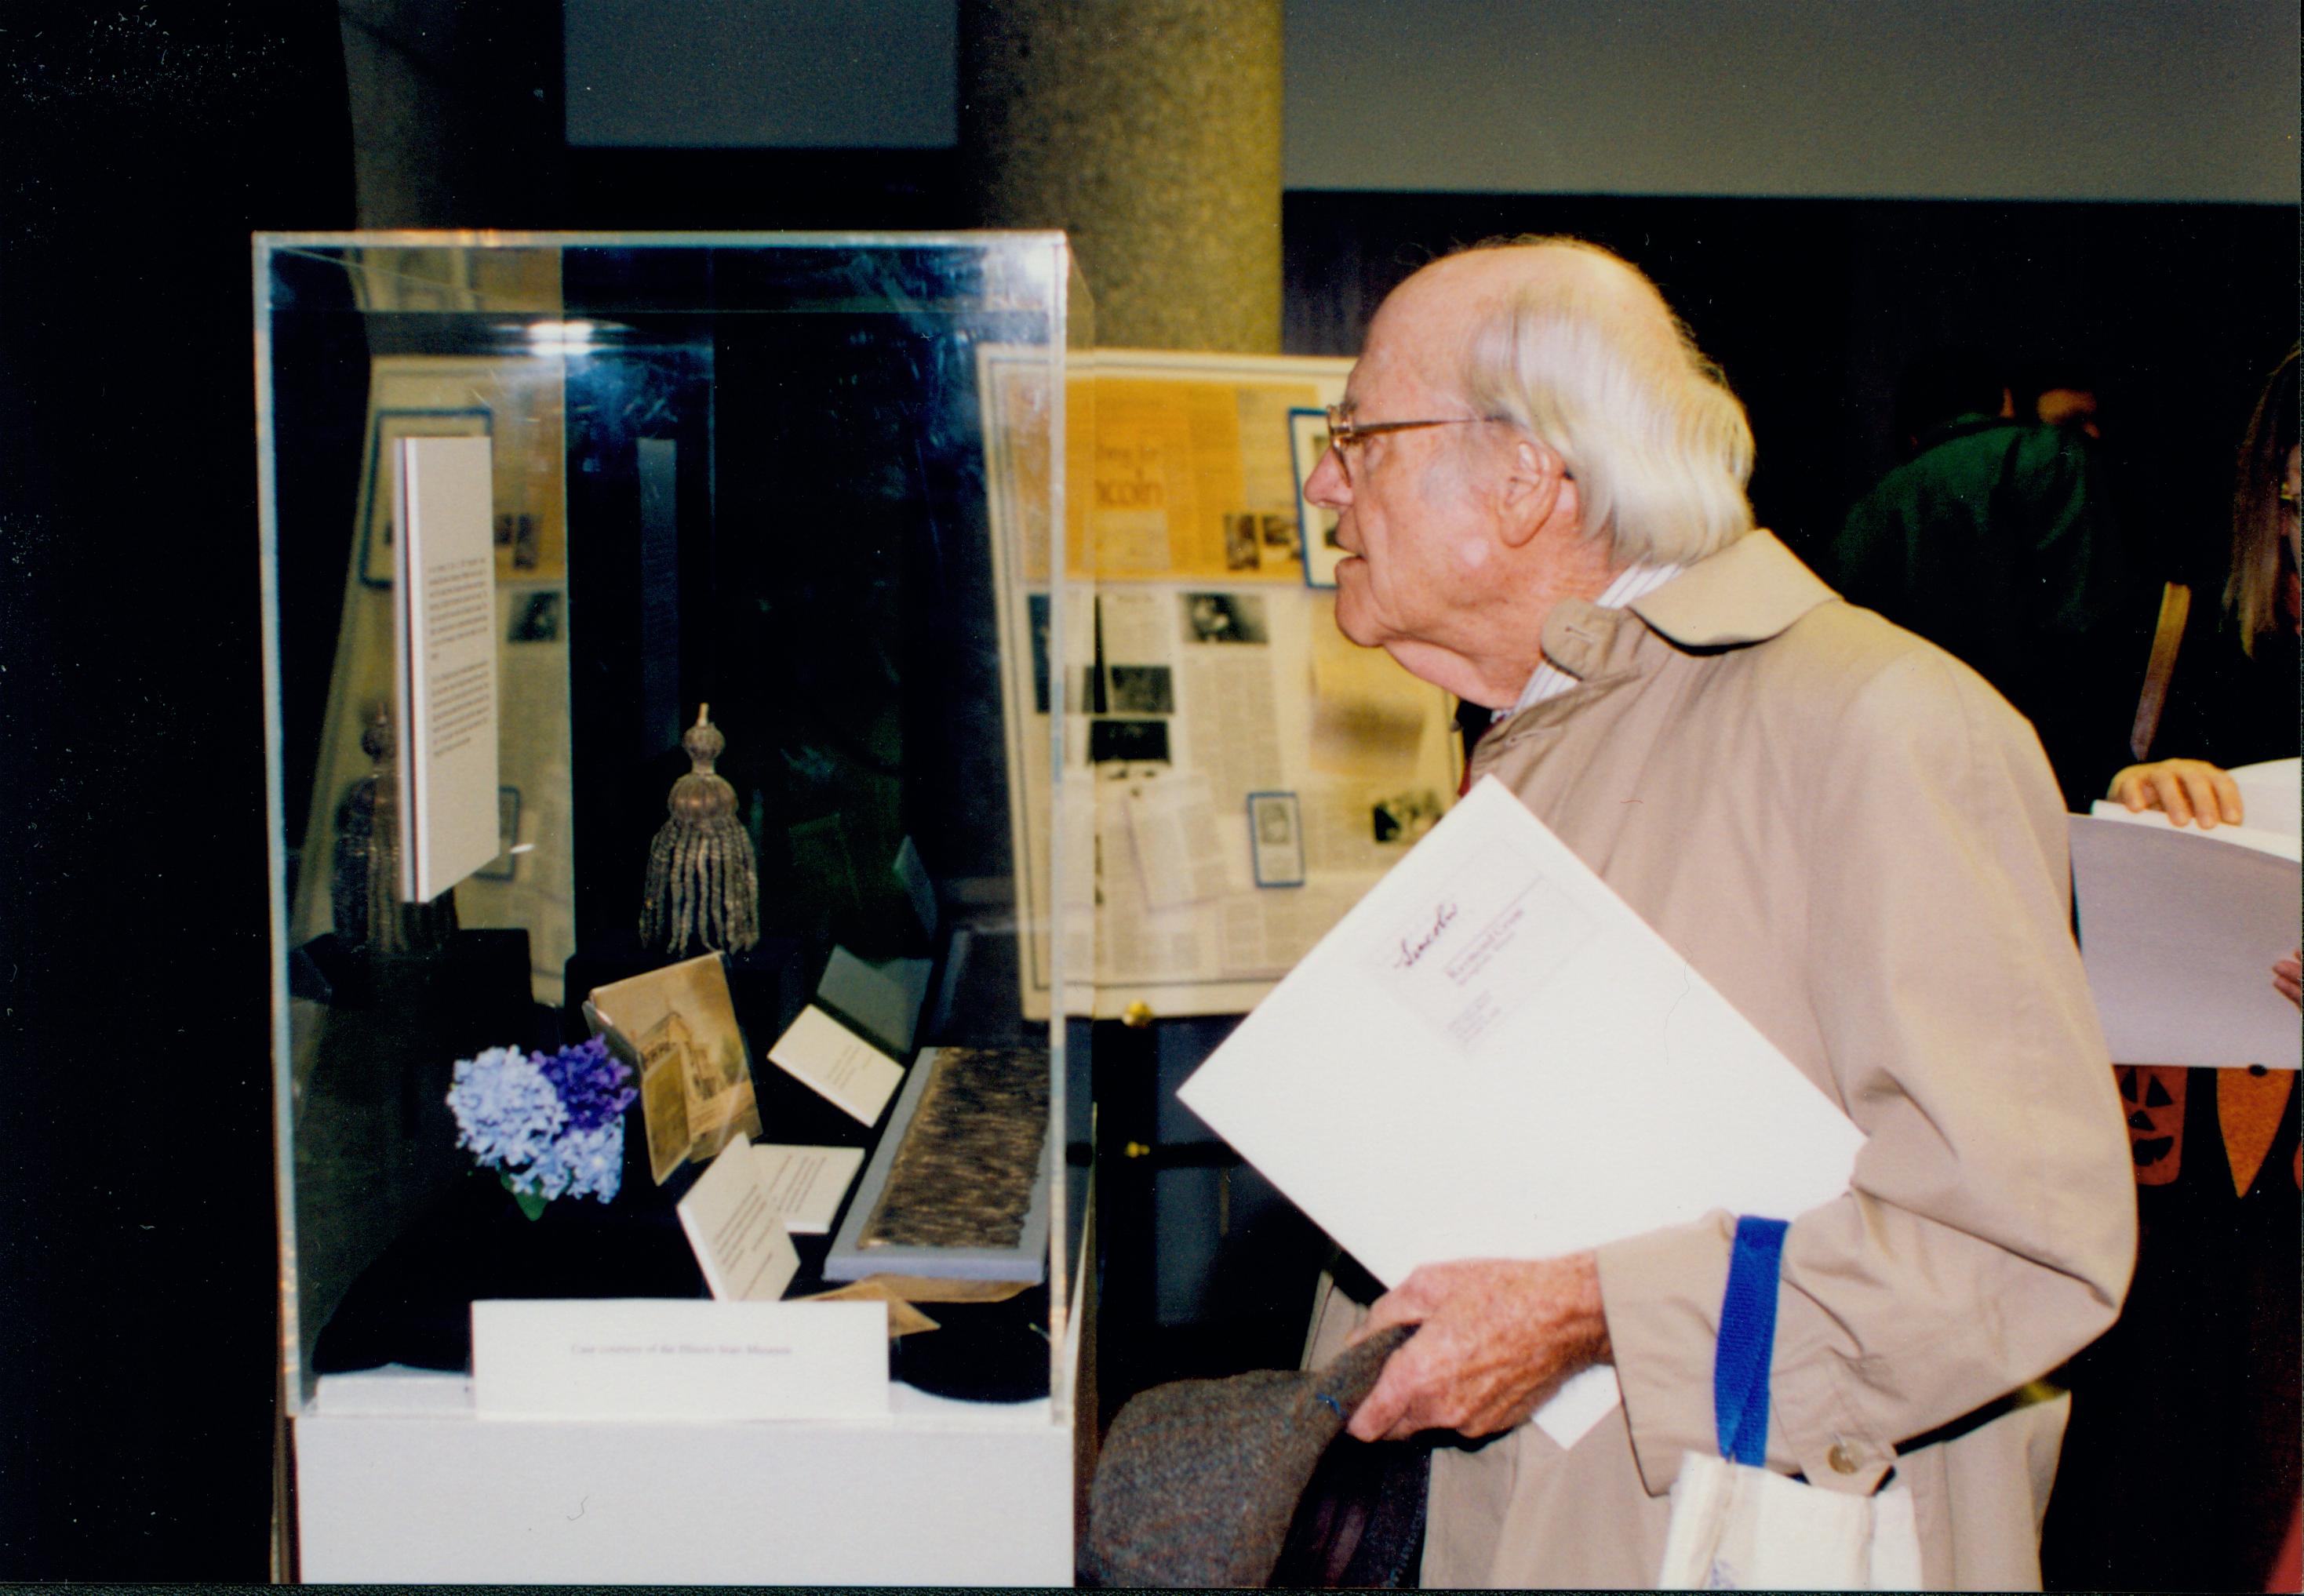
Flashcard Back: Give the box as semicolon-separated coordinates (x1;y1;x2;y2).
1350;1252;1608;1441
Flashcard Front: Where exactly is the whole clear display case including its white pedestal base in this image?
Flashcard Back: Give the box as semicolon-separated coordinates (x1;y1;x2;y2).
256;233;1094;1584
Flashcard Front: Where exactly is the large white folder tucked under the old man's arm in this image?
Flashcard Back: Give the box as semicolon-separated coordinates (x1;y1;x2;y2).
1177;779;1864;1444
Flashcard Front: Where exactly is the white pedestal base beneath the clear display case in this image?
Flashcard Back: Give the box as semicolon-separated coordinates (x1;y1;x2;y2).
295;1370;1074;1584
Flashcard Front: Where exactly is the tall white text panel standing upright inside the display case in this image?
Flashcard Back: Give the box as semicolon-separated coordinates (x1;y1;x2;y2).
391;438;502;903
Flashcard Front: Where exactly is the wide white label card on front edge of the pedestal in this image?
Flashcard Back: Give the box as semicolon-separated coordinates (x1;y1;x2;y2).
472;1296;887;1421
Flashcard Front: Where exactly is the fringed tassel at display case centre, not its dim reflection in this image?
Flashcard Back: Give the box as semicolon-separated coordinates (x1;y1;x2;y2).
640;705;760;956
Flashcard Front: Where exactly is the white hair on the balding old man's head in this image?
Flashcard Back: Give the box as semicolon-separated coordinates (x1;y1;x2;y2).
1463;237;1751;564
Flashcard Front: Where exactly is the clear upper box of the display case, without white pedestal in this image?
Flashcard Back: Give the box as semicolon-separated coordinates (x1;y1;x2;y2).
256;233;1094;1423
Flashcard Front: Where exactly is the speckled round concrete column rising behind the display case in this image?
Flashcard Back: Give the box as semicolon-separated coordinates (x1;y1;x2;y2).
961;0;1281;354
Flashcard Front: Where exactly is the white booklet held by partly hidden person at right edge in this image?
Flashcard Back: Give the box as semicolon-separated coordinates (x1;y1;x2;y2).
2071;797;2304;1069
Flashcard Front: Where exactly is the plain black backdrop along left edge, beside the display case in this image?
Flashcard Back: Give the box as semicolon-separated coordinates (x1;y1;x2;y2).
0;0;352;1582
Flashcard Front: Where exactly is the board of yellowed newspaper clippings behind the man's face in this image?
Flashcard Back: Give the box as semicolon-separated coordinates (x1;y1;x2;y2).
981;350;1456;1016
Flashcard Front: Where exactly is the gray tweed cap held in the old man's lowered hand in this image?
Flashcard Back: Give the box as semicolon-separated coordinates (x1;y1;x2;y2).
1085;1324;1414;1587
